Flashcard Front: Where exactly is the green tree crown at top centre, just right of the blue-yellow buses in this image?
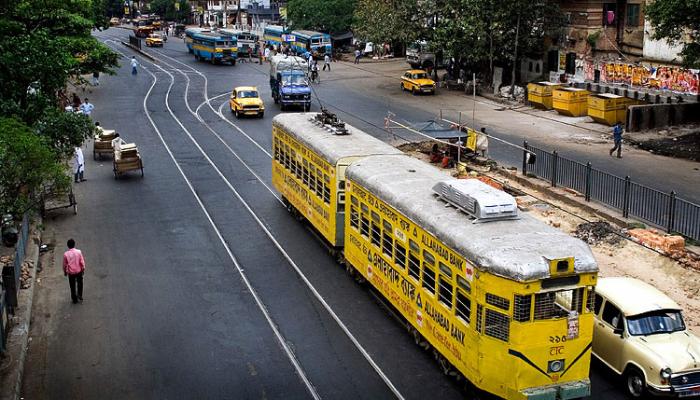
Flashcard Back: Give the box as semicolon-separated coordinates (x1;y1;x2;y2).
352;0;424;45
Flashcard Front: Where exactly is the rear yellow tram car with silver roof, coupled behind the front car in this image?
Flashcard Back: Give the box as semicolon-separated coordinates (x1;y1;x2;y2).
272;113;402;248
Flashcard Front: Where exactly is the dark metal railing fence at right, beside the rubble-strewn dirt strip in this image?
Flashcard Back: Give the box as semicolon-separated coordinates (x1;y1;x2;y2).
523;142;700;240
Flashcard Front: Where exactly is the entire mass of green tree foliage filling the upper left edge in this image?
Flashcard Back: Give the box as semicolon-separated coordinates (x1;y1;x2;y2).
0;0;118;213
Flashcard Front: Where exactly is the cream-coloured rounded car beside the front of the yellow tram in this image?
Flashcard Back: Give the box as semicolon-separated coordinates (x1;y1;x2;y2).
593;277;700;398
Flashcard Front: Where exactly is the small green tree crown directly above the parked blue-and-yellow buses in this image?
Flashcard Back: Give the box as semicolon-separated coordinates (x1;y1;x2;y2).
287;0;356;33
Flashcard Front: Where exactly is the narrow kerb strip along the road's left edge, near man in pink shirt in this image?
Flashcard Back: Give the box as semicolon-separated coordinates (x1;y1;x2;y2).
0;219;42;400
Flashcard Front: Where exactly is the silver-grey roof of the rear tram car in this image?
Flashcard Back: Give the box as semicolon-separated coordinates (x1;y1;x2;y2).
272;113;403;165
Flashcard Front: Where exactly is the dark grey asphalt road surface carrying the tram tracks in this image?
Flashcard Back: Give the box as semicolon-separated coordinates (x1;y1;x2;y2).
23;29;623;399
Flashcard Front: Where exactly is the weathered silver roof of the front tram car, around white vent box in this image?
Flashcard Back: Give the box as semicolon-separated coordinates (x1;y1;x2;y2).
346;155;598;281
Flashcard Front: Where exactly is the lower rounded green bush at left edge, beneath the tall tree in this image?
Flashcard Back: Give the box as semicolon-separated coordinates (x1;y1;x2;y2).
0;118;70;215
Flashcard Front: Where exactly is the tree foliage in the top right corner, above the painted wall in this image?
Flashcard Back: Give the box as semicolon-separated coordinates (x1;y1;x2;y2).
644;0;700;68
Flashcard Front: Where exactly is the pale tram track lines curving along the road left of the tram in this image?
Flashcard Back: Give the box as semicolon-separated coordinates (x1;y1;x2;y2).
100;34;404;399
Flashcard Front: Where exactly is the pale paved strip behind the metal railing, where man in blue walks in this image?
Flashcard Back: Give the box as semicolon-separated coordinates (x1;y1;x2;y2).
334;59;700;203
